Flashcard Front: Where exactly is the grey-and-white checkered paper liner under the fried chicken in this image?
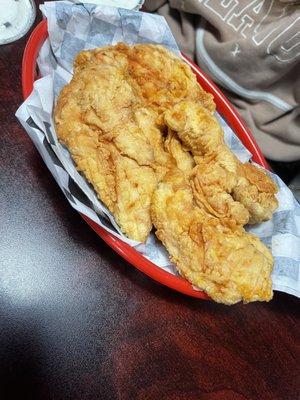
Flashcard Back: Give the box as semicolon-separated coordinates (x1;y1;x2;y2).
16;1;300;297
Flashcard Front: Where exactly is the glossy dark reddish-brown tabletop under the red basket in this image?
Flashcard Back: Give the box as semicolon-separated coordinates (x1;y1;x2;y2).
0;1;300;400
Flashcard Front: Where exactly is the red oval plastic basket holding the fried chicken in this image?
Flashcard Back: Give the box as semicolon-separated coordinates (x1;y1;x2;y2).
22;20;268;300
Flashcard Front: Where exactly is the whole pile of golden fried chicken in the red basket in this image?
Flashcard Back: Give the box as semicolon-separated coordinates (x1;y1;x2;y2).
55;44;277;304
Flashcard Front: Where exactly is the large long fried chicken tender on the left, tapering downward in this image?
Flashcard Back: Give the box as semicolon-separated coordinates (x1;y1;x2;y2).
55;54;157;241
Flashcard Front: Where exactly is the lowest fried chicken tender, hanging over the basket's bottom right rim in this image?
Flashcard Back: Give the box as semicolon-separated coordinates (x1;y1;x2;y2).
151;169;273;304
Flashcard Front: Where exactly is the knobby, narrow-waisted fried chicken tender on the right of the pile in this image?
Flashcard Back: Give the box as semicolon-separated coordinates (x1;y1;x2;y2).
164;100;278;226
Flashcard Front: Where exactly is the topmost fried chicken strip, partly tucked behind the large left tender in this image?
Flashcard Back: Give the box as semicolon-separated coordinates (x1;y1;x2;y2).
75;43;216;114
